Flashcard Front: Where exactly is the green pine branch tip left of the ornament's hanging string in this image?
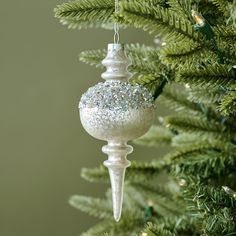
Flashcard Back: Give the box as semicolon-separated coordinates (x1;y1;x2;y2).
54;0;114;29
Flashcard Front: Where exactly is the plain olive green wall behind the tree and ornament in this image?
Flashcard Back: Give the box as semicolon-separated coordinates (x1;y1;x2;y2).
0;0;164;236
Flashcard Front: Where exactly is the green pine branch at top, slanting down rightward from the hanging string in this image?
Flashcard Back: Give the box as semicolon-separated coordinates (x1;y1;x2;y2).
121;0;199;40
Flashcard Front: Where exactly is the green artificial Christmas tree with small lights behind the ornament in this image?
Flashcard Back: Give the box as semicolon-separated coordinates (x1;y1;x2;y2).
55;0;236;236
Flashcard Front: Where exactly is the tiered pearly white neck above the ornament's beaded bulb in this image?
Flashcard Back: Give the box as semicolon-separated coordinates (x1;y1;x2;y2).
102;43;131;82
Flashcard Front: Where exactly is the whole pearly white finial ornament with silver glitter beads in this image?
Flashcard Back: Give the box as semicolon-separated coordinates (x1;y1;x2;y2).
79;44;155;221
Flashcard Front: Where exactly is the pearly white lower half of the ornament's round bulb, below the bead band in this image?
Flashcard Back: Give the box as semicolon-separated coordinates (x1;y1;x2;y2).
80;107;154;143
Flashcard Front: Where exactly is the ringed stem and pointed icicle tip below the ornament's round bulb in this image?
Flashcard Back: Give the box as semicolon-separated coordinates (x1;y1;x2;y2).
102;142;133;221
